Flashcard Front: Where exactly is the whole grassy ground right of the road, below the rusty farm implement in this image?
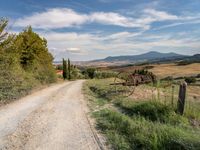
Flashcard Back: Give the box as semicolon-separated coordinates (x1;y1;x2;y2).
83;79;200;150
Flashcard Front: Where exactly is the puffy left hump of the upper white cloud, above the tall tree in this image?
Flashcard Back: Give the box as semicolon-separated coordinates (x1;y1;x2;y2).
15;8;88;29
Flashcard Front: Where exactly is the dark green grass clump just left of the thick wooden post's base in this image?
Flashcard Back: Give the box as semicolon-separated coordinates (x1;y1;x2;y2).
116;100;189;125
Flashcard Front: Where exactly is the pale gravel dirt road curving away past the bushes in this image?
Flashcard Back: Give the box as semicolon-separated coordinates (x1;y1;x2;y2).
0;81;99;150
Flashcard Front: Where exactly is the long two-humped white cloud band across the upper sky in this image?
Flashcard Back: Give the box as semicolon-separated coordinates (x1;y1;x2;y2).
15;8;144;29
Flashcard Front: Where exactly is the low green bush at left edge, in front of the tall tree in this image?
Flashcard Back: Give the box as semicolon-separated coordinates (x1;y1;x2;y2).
0;53;39;102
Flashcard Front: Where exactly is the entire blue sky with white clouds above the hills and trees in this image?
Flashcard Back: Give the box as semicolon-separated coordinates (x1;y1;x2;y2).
0;0;200;60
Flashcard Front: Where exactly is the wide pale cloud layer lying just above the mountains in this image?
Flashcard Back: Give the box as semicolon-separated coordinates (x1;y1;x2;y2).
36;29;200;60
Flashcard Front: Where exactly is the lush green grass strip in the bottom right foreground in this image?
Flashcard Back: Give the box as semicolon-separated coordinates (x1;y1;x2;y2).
95;110;200;150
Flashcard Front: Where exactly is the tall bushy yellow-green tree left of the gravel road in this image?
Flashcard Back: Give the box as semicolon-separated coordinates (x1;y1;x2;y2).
14;27;56;83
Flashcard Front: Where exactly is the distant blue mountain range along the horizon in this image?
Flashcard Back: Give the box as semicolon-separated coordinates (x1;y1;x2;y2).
54;51;200;66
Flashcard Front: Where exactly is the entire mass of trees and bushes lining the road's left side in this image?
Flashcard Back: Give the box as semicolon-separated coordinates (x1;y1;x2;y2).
0;19;56;103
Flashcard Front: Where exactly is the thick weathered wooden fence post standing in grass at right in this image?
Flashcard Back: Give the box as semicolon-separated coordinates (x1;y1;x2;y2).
177;82;187;115
